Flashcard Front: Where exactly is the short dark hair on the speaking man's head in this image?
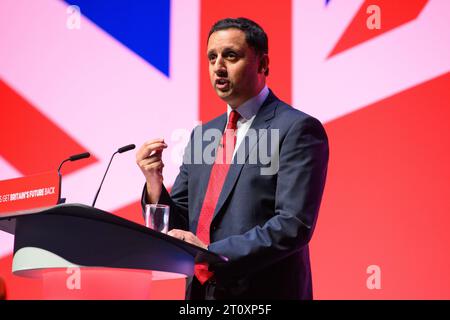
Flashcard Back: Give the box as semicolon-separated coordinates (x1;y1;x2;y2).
208;17;269;75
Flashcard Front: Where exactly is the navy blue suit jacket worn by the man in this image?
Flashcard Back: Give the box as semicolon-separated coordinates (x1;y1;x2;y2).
144;92;328;299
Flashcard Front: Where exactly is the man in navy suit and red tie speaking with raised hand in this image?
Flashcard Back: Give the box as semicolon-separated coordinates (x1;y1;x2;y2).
136;18;328;299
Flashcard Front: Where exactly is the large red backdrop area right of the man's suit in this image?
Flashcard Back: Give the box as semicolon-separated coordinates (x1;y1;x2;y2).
311;73;450;299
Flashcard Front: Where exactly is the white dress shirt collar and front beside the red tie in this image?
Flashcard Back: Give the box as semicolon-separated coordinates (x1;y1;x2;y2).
225;86;269;157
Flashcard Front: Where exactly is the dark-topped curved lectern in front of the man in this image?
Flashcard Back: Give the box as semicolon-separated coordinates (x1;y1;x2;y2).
0;204;227;299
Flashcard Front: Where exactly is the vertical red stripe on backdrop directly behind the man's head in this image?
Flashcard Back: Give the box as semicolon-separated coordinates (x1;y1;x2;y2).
199;0;292;122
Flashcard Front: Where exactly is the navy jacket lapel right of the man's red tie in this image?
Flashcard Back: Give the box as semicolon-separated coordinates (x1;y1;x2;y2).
211;91;279;219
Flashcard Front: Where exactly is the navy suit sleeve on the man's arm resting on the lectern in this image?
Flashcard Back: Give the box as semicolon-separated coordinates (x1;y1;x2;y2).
208;117;328;278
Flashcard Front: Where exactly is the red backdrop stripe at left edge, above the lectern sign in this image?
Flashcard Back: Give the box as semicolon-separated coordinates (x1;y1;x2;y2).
0;80;97;175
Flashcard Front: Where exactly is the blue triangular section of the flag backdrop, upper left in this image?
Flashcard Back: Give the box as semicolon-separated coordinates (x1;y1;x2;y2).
66;0;170;76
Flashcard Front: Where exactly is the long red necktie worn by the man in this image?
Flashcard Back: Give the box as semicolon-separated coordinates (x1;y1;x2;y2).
195;110;240;284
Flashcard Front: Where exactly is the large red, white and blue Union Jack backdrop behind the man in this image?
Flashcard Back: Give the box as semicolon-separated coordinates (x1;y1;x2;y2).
0;0;450;299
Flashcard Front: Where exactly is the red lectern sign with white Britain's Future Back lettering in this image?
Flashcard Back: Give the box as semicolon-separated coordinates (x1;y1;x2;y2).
0;171;60;216
